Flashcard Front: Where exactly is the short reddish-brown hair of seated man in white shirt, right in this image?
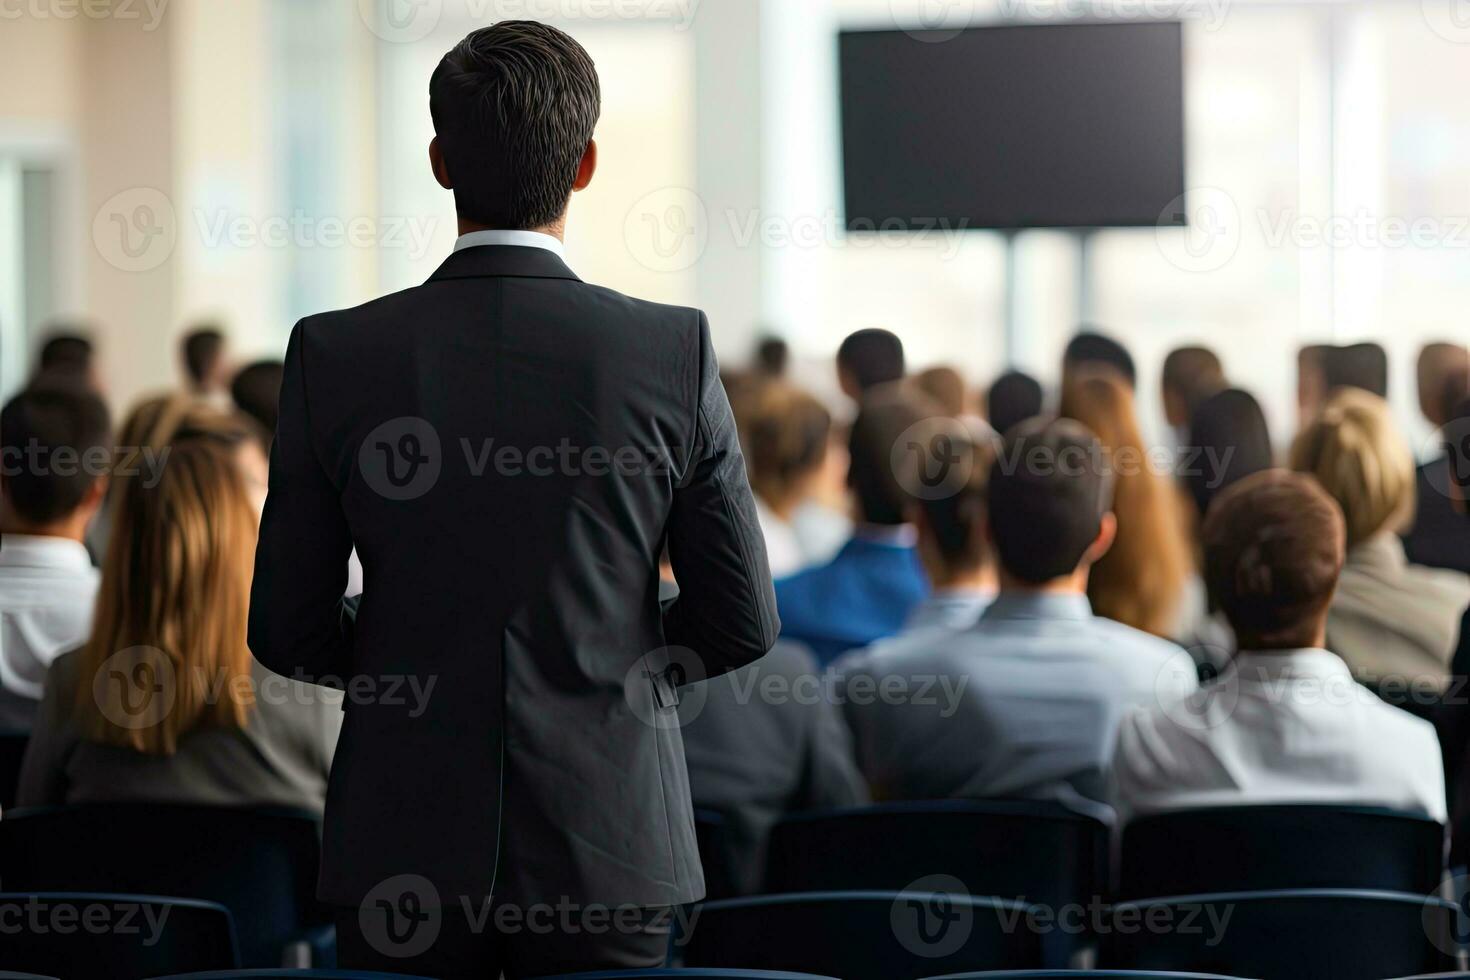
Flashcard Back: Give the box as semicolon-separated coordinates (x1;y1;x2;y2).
1202;470;1347;649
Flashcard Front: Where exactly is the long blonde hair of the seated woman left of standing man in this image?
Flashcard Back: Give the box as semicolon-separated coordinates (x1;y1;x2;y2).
76;403;257;755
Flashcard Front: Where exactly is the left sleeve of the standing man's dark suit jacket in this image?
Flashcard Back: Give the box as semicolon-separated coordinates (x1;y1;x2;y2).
250;323;353;686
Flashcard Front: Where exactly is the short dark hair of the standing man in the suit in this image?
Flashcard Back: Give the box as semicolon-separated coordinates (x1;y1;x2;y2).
429;21;603;229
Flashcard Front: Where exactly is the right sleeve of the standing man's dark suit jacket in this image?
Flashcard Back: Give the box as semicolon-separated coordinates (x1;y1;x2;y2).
663;313;781;683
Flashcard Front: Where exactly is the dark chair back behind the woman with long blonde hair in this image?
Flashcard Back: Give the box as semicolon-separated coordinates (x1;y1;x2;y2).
0;804;326;967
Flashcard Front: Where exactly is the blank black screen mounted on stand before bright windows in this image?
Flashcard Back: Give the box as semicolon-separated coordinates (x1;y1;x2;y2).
839;22;1185;231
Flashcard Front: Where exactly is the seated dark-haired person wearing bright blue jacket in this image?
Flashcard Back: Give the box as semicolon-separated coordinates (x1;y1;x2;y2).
776;385;942;666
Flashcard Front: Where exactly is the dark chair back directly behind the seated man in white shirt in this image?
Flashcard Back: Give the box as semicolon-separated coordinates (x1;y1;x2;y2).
1119;805;1445;899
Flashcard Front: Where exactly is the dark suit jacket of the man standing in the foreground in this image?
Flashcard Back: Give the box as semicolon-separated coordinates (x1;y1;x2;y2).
250;245;779;905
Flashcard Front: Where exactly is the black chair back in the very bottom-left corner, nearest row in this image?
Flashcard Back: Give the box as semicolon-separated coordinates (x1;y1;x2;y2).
0;892;240;980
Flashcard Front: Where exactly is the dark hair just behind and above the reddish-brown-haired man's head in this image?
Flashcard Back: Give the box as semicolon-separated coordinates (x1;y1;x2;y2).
1180;388;1276;519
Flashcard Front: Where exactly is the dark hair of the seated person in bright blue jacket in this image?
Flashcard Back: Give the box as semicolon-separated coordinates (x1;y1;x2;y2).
847;383;944;526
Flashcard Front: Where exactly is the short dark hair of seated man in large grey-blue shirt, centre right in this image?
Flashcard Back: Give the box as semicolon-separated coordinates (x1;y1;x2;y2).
988;419;1111;585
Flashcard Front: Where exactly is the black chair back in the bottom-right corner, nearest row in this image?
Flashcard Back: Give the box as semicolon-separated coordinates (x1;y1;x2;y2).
1098;889;1457;980
